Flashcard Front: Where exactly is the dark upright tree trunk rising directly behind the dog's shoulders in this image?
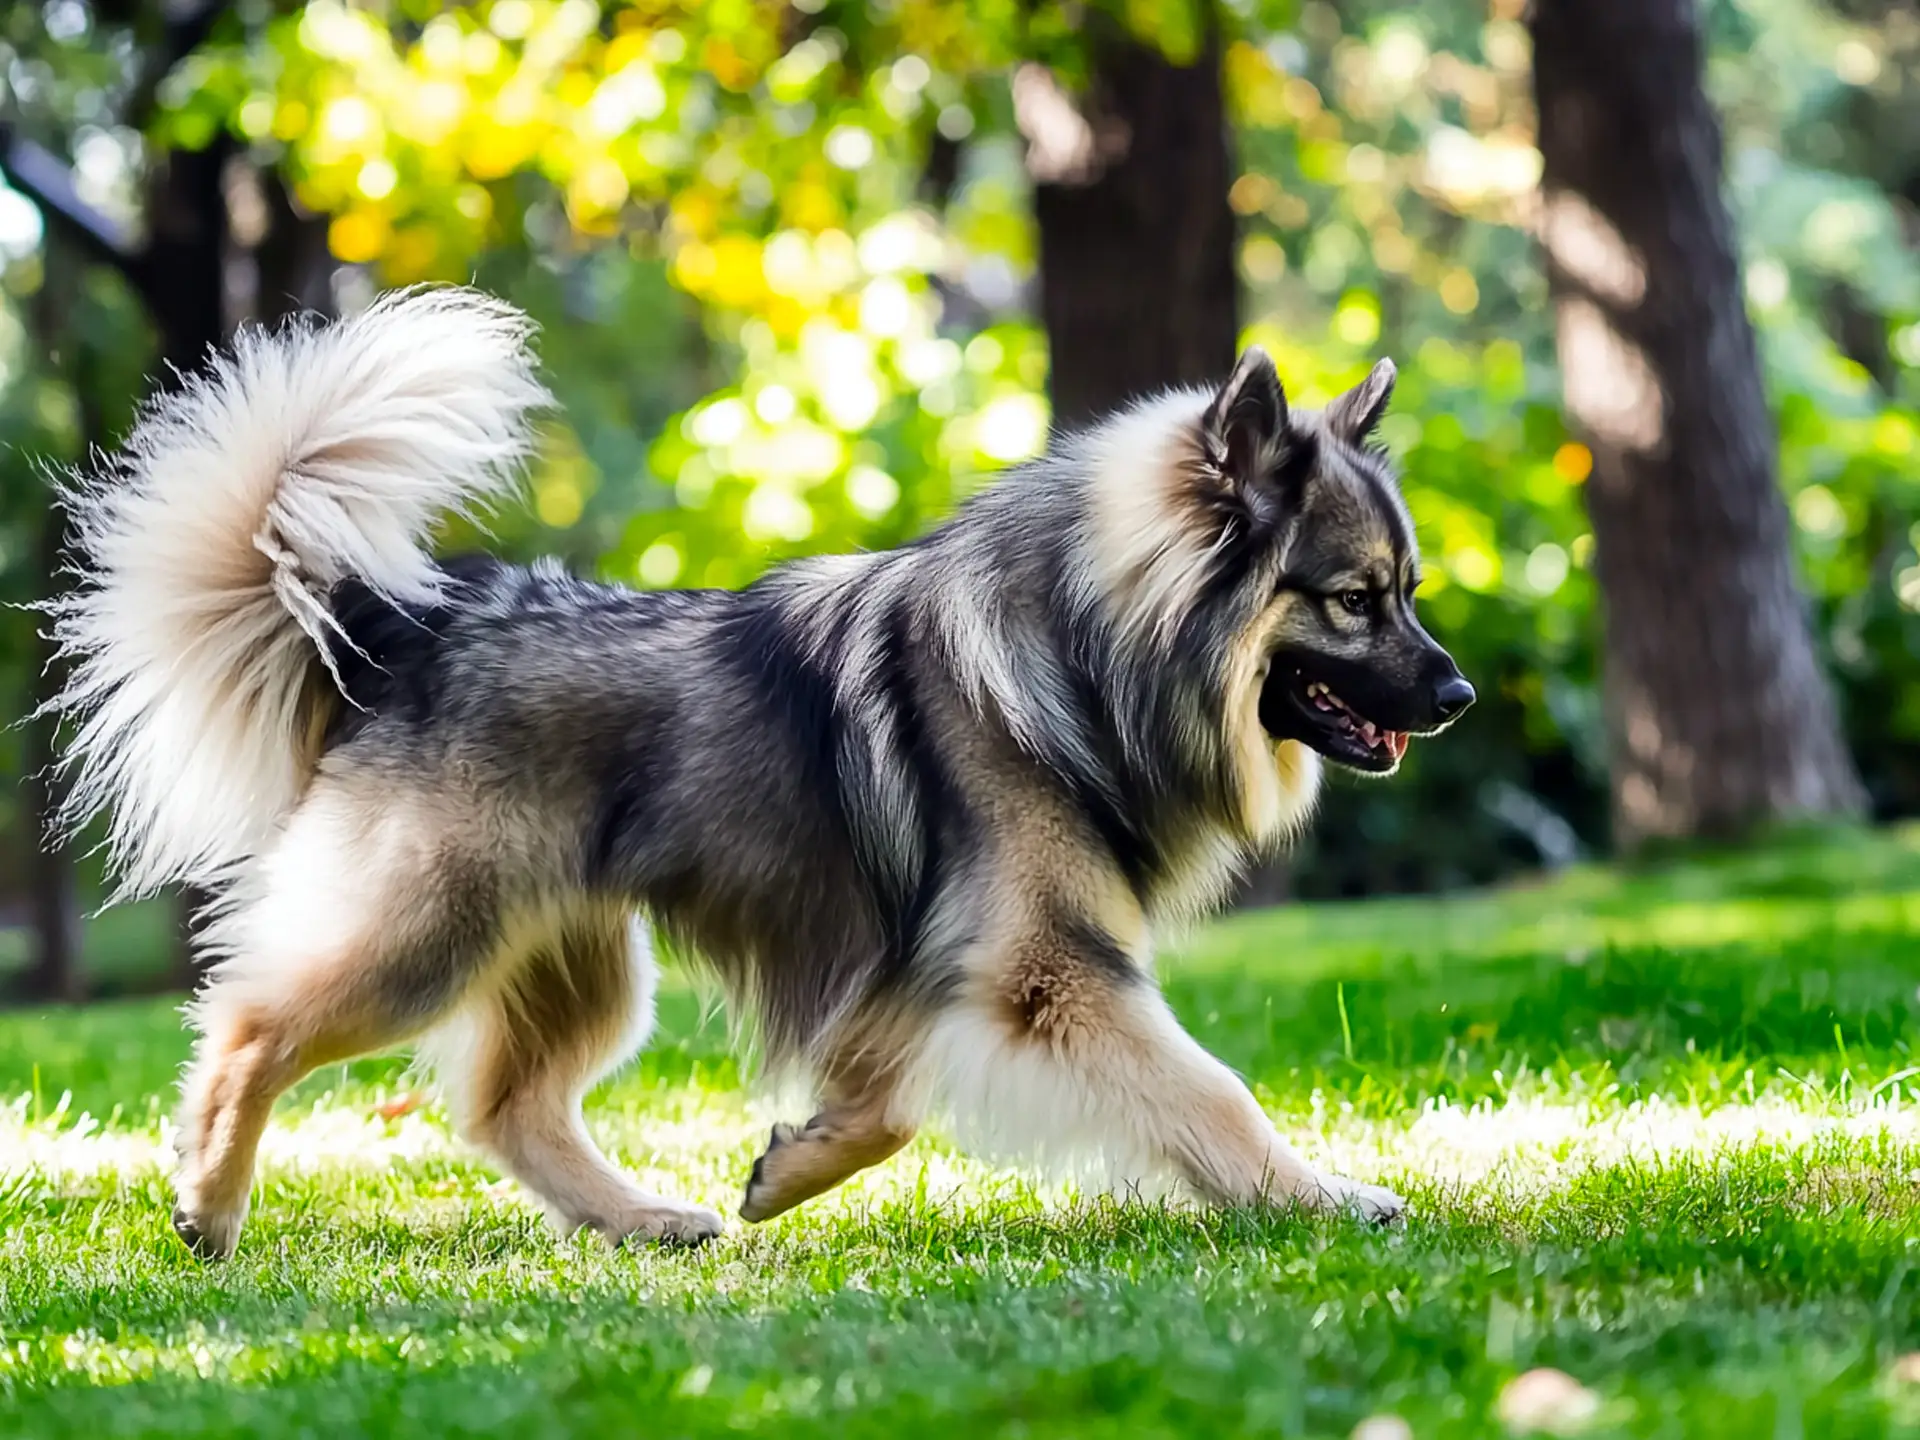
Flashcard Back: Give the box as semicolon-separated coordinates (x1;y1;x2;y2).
1014;12;1238;424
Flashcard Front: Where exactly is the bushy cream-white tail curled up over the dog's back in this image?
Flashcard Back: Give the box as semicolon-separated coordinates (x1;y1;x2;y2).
48;288;547;895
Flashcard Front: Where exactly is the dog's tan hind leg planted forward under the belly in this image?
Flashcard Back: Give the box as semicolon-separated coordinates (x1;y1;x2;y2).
430;904;720;1244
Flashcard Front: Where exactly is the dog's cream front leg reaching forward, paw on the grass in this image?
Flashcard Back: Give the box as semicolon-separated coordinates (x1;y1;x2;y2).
925;935;1404;1223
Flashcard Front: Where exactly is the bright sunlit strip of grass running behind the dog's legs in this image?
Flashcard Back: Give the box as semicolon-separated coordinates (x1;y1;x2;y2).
11;1068;1920;1231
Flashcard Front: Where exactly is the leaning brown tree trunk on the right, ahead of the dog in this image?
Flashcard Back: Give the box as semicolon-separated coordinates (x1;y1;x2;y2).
1530;0;1862;845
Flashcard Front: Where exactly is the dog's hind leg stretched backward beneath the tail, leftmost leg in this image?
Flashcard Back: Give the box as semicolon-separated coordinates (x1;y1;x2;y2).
173;797;493;1260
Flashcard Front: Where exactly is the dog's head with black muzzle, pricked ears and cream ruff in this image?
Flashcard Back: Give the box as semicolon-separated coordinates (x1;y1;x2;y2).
1096;349;1473;852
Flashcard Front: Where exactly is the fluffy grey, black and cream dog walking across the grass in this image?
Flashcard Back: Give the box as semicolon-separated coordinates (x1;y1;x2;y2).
52;290;1473;1258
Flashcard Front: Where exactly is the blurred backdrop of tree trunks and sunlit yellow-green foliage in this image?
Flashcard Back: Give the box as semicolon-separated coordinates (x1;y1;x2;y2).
0;0;1920;998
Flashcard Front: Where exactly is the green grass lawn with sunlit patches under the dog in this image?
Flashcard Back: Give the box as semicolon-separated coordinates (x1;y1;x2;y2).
0;831;1920;1440
